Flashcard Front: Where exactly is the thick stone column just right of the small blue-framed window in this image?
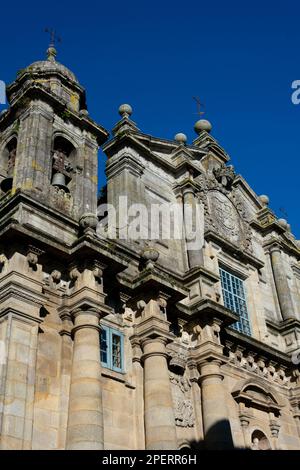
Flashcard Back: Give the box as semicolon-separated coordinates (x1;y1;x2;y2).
142;337;178;450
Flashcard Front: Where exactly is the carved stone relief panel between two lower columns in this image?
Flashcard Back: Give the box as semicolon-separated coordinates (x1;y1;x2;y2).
170;374;195;428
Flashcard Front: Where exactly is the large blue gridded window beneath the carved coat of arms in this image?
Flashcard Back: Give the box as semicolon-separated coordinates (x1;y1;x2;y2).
220;268;251;336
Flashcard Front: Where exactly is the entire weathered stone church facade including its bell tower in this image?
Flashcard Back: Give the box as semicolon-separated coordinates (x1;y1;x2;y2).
0;45;300;450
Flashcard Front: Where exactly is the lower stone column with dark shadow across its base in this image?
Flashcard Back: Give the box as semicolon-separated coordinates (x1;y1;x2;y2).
199;359;233;450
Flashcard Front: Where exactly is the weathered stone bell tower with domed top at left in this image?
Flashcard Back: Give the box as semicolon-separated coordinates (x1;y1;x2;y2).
0;42;108;221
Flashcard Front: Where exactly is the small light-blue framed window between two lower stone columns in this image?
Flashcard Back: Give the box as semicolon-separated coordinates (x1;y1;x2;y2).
100;326;124;372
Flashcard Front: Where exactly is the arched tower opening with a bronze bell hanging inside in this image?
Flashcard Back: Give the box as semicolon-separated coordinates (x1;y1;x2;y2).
51;136;76;192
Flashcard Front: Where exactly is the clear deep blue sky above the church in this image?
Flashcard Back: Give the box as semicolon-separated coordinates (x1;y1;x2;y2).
0;0;300;238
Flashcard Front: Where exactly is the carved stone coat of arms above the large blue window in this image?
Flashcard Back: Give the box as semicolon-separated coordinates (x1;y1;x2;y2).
197;165;253;253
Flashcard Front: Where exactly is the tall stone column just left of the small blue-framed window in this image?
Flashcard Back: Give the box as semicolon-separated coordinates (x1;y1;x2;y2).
66;308;103;450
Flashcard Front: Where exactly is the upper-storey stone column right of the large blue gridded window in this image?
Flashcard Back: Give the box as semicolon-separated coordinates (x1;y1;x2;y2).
270;245;296;320
